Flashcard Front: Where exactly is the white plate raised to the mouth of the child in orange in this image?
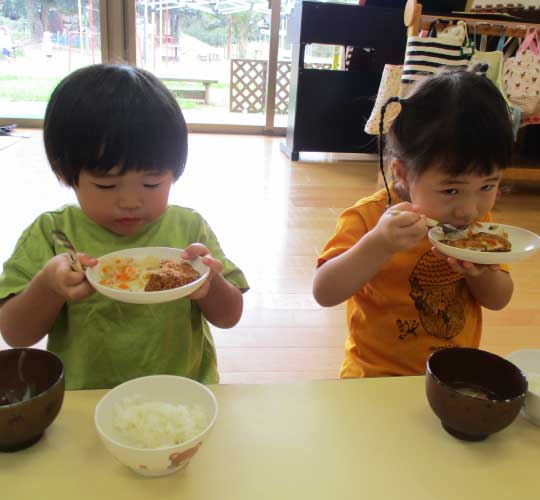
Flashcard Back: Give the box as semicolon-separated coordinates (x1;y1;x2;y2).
428;222;540;264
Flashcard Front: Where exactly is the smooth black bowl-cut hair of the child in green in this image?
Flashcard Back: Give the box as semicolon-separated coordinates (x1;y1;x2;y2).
43;64;188;187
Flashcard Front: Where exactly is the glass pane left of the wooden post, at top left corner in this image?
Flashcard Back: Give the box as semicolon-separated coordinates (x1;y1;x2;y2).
0;0;101;120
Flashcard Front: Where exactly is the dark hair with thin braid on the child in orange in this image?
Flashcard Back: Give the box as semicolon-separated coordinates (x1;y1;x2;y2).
379;70;514;205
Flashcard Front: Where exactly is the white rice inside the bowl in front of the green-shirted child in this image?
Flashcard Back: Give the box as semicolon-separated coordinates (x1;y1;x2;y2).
113;395;209;449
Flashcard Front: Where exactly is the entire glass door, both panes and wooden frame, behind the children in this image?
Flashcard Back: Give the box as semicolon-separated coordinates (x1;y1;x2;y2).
0;0;293;133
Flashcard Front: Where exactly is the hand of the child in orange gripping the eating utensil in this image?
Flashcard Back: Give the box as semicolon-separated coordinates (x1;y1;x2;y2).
373;202;429;254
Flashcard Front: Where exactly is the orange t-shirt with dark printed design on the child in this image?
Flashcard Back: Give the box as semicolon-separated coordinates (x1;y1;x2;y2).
318;186;506;378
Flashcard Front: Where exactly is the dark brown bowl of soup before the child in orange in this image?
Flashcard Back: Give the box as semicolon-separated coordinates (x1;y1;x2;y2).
426;347;527;441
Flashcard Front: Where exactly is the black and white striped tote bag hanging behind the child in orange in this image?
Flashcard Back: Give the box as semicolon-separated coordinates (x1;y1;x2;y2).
399;21;474;97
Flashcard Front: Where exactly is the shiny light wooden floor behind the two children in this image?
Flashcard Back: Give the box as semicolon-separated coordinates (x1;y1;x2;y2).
0;131;540;383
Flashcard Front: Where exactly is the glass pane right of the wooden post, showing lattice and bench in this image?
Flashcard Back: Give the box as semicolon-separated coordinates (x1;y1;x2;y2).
135;0;279;130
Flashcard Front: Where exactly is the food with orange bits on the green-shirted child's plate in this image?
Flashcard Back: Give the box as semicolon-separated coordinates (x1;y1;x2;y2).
99;257;201;292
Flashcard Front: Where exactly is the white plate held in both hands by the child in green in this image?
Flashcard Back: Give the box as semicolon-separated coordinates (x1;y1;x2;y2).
86;247;210;304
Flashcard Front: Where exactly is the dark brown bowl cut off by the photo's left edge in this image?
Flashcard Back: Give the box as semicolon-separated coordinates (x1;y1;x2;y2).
0;348;64;451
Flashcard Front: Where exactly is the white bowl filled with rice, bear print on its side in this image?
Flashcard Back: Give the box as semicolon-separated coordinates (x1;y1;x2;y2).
94;375;218;476
